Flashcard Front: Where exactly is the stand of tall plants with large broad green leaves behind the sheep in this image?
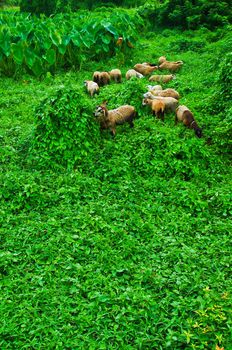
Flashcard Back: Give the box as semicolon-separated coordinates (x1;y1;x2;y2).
0;11;143;77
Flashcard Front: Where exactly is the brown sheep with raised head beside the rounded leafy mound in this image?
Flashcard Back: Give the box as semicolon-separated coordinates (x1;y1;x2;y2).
94;101;136;136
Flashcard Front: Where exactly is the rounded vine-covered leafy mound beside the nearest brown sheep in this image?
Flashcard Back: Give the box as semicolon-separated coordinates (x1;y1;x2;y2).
31;88;99;169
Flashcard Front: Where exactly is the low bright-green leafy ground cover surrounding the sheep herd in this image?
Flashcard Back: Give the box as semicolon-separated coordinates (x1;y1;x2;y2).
0;19;232;350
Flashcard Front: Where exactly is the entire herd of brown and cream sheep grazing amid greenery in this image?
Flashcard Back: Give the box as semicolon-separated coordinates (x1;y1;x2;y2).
84;56;202;137
